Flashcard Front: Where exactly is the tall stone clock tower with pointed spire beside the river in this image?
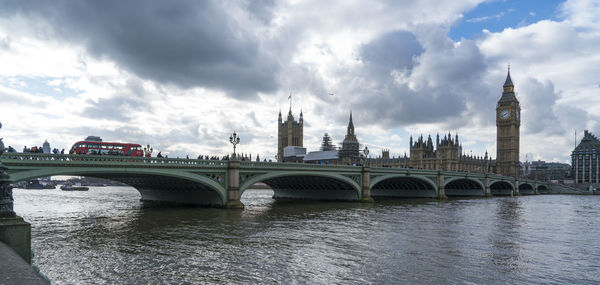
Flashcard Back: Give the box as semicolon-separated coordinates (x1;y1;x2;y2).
496;67;521;177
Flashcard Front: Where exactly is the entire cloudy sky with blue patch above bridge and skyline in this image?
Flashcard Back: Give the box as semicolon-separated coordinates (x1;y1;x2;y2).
0;0;600;162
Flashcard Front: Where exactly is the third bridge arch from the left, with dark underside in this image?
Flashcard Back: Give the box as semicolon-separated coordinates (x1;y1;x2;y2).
371;174;438;198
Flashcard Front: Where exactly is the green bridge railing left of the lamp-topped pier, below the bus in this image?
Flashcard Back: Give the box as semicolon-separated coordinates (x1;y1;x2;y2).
0;153;227;168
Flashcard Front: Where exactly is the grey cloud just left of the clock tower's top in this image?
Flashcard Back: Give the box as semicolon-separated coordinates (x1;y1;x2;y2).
347;31;495;127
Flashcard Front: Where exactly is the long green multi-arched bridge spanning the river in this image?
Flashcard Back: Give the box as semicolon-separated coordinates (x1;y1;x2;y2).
0;153;549;208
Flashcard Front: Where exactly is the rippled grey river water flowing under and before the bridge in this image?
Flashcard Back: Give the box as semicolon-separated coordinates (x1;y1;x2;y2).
14;187;600;284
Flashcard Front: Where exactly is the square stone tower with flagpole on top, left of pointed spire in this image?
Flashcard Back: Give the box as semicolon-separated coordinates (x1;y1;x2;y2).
277;106;304;162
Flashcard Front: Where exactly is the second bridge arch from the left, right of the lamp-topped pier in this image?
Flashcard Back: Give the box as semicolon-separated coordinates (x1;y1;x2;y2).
240;171;362;201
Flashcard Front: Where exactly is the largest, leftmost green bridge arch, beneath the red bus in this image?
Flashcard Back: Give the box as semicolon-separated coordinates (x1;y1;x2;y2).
10;167;227;206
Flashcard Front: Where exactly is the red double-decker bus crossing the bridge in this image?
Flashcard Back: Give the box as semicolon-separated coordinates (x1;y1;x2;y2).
69;136;144;156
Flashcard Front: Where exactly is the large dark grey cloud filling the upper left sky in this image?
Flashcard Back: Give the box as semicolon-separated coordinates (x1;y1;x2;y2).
0;0;280;98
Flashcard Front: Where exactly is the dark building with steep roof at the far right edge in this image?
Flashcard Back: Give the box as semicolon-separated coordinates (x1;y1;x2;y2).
571;130;600;184
